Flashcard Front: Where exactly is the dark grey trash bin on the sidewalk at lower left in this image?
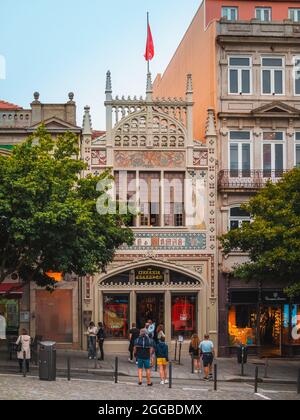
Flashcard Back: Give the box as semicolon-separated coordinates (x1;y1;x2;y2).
39;341;56;381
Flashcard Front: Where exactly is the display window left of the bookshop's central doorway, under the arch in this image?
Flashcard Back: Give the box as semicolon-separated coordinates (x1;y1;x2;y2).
103;294;129;339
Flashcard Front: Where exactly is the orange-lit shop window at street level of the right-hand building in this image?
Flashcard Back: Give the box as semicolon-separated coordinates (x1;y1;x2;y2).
228;305;257;346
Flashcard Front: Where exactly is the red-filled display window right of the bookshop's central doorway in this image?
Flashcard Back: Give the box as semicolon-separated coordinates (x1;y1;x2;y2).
172;295;197;338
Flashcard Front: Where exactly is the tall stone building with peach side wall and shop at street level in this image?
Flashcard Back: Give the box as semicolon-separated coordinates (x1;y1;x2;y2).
154;0;300;356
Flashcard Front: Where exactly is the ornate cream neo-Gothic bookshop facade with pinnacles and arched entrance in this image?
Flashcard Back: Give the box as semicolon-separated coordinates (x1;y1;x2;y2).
82;72;218;351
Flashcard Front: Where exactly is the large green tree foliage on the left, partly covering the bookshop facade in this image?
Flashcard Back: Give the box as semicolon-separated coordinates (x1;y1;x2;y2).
0;127;133;288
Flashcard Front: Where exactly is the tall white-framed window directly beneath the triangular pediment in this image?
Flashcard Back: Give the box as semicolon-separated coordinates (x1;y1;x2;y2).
262;131;285;178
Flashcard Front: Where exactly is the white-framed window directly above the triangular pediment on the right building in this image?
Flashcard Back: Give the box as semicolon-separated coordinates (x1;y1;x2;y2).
261;57;285;95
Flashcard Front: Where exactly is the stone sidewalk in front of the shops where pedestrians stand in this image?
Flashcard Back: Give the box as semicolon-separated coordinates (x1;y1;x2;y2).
0;350;300;384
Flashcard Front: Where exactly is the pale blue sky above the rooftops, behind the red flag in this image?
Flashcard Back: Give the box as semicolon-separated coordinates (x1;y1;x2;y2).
0;0;201;129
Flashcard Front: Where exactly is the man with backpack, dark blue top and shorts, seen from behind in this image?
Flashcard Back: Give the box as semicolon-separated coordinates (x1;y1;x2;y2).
134;329;154;386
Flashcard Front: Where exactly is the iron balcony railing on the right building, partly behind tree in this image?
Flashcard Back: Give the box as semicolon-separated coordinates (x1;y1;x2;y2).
218;169;288;190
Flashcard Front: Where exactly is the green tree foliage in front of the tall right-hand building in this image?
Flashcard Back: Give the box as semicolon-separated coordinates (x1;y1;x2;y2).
220;168;300;296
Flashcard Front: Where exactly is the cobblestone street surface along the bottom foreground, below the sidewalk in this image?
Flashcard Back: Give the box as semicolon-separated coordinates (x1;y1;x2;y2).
0;375;300;401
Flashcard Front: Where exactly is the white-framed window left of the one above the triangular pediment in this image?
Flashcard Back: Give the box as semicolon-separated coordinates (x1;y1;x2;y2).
228;56;252;95
